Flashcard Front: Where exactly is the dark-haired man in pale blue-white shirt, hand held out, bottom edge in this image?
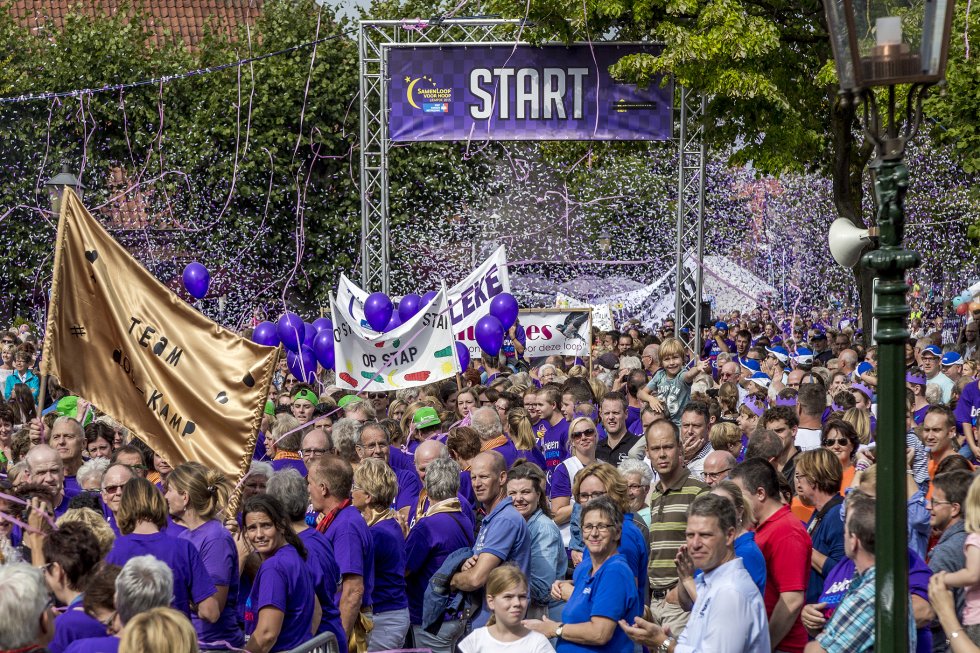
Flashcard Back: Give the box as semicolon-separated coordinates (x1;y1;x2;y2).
619;494;771;653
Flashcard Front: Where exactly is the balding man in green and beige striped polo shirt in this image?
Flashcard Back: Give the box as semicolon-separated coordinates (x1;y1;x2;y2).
645;419;708;637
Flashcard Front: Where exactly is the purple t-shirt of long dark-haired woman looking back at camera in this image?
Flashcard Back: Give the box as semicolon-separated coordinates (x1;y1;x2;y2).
245;544;316;651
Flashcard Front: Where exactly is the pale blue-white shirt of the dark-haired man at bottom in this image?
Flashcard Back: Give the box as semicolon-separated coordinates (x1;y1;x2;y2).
674;558;771;653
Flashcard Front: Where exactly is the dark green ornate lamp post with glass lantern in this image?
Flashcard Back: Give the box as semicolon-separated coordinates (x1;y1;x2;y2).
824;0;954;651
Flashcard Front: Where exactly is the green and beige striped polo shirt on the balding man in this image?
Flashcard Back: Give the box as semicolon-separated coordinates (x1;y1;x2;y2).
647;469;708;590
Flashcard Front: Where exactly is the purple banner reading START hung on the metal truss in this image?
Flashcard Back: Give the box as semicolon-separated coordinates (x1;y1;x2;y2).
388;43;673;141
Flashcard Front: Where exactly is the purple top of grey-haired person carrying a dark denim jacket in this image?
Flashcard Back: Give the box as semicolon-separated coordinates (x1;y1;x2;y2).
405;513;473;625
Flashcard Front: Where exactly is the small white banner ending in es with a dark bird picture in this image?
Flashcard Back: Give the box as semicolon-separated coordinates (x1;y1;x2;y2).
520;308;592;359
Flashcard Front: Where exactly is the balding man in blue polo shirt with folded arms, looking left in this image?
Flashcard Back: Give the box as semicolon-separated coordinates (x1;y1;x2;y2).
451;451;531;628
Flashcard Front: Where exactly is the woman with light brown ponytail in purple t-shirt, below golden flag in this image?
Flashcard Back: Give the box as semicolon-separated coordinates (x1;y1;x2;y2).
164;462;244;650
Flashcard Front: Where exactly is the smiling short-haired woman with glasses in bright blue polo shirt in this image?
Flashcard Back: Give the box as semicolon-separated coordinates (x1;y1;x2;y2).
524;497;643;653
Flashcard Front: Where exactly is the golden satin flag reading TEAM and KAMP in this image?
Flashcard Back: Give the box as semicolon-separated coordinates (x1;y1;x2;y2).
41;189;277;479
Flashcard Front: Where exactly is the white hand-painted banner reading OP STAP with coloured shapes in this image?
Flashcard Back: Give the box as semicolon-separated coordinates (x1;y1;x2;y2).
331;287;461;392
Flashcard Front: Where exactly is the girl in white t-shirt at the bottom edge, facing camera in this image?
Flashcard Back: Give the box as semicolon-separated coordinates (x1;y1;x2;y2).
459;564;555;653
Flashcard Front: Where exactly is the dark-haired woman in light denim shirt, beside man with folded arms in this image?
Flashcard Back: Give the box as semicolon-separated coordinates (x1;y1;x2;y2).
507;460;568;621
